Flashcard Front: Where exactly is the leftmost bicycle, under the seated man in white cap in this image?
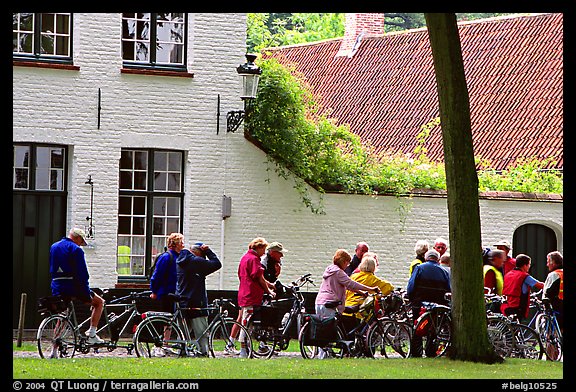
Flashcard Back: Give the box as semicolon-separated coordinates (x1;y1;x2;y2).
36;291;150;358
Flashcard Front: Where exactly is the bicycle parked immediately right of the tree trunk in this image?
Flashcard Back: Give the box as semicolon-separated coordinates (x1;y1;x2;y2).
486;294;544;359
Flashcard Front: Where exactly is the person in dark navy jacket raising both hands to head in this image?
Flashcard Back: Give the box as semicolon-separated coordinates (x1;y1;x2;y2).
176;242;222;356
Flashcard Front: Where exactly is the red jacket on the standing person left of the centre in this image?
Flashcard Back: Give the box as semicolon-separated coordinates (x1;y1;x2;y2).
238;249;264;307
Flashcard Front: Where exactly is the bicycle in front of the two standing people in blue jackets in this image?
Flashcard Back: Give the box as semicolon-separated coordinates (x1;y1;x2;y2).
133;294;252;358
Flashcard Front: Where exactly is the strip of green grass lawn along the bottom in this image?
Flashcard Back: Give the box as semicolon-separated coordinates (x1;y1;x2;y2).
12;350;564;380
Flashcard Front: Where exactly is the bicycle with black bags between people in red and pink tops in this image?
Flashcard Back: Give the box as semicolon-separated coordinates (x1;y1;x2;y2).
247;274;314;359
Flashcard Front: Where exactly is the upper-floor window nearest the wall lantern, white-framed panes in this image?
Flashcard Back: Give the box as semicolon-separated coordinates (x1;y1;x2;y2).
122;13;186;68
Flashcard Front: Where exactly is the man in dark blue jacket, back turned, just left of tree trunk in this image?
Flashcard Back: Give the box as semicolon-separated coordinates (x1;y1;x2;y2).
406;249;451;357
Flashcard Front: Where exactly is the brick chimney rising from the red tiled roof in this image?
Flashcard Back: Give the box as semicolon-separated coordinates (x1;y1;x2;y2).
336;14;384;57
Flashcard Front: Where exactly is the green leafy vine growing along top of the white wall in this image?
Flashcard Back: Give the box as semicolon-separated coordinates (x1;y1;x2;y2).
246;59;563;213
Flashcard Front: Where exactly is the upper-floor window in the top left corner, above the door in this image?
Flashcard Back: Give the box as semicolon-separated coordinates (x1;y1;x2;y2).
12;12;72;61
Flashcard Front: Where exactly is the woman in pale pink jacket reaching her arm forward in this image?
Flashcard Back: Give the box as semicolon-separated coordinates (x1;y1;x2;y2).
316;249;378;318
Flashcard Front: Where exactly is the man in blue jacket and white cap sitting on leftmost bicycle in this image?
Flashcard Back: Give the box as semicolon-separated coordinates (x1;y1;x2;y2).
50;227;104;344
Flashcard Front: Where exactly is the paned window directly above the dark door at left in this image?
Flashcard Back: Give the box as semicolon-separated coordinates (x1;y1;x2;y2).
12;144;66;191
